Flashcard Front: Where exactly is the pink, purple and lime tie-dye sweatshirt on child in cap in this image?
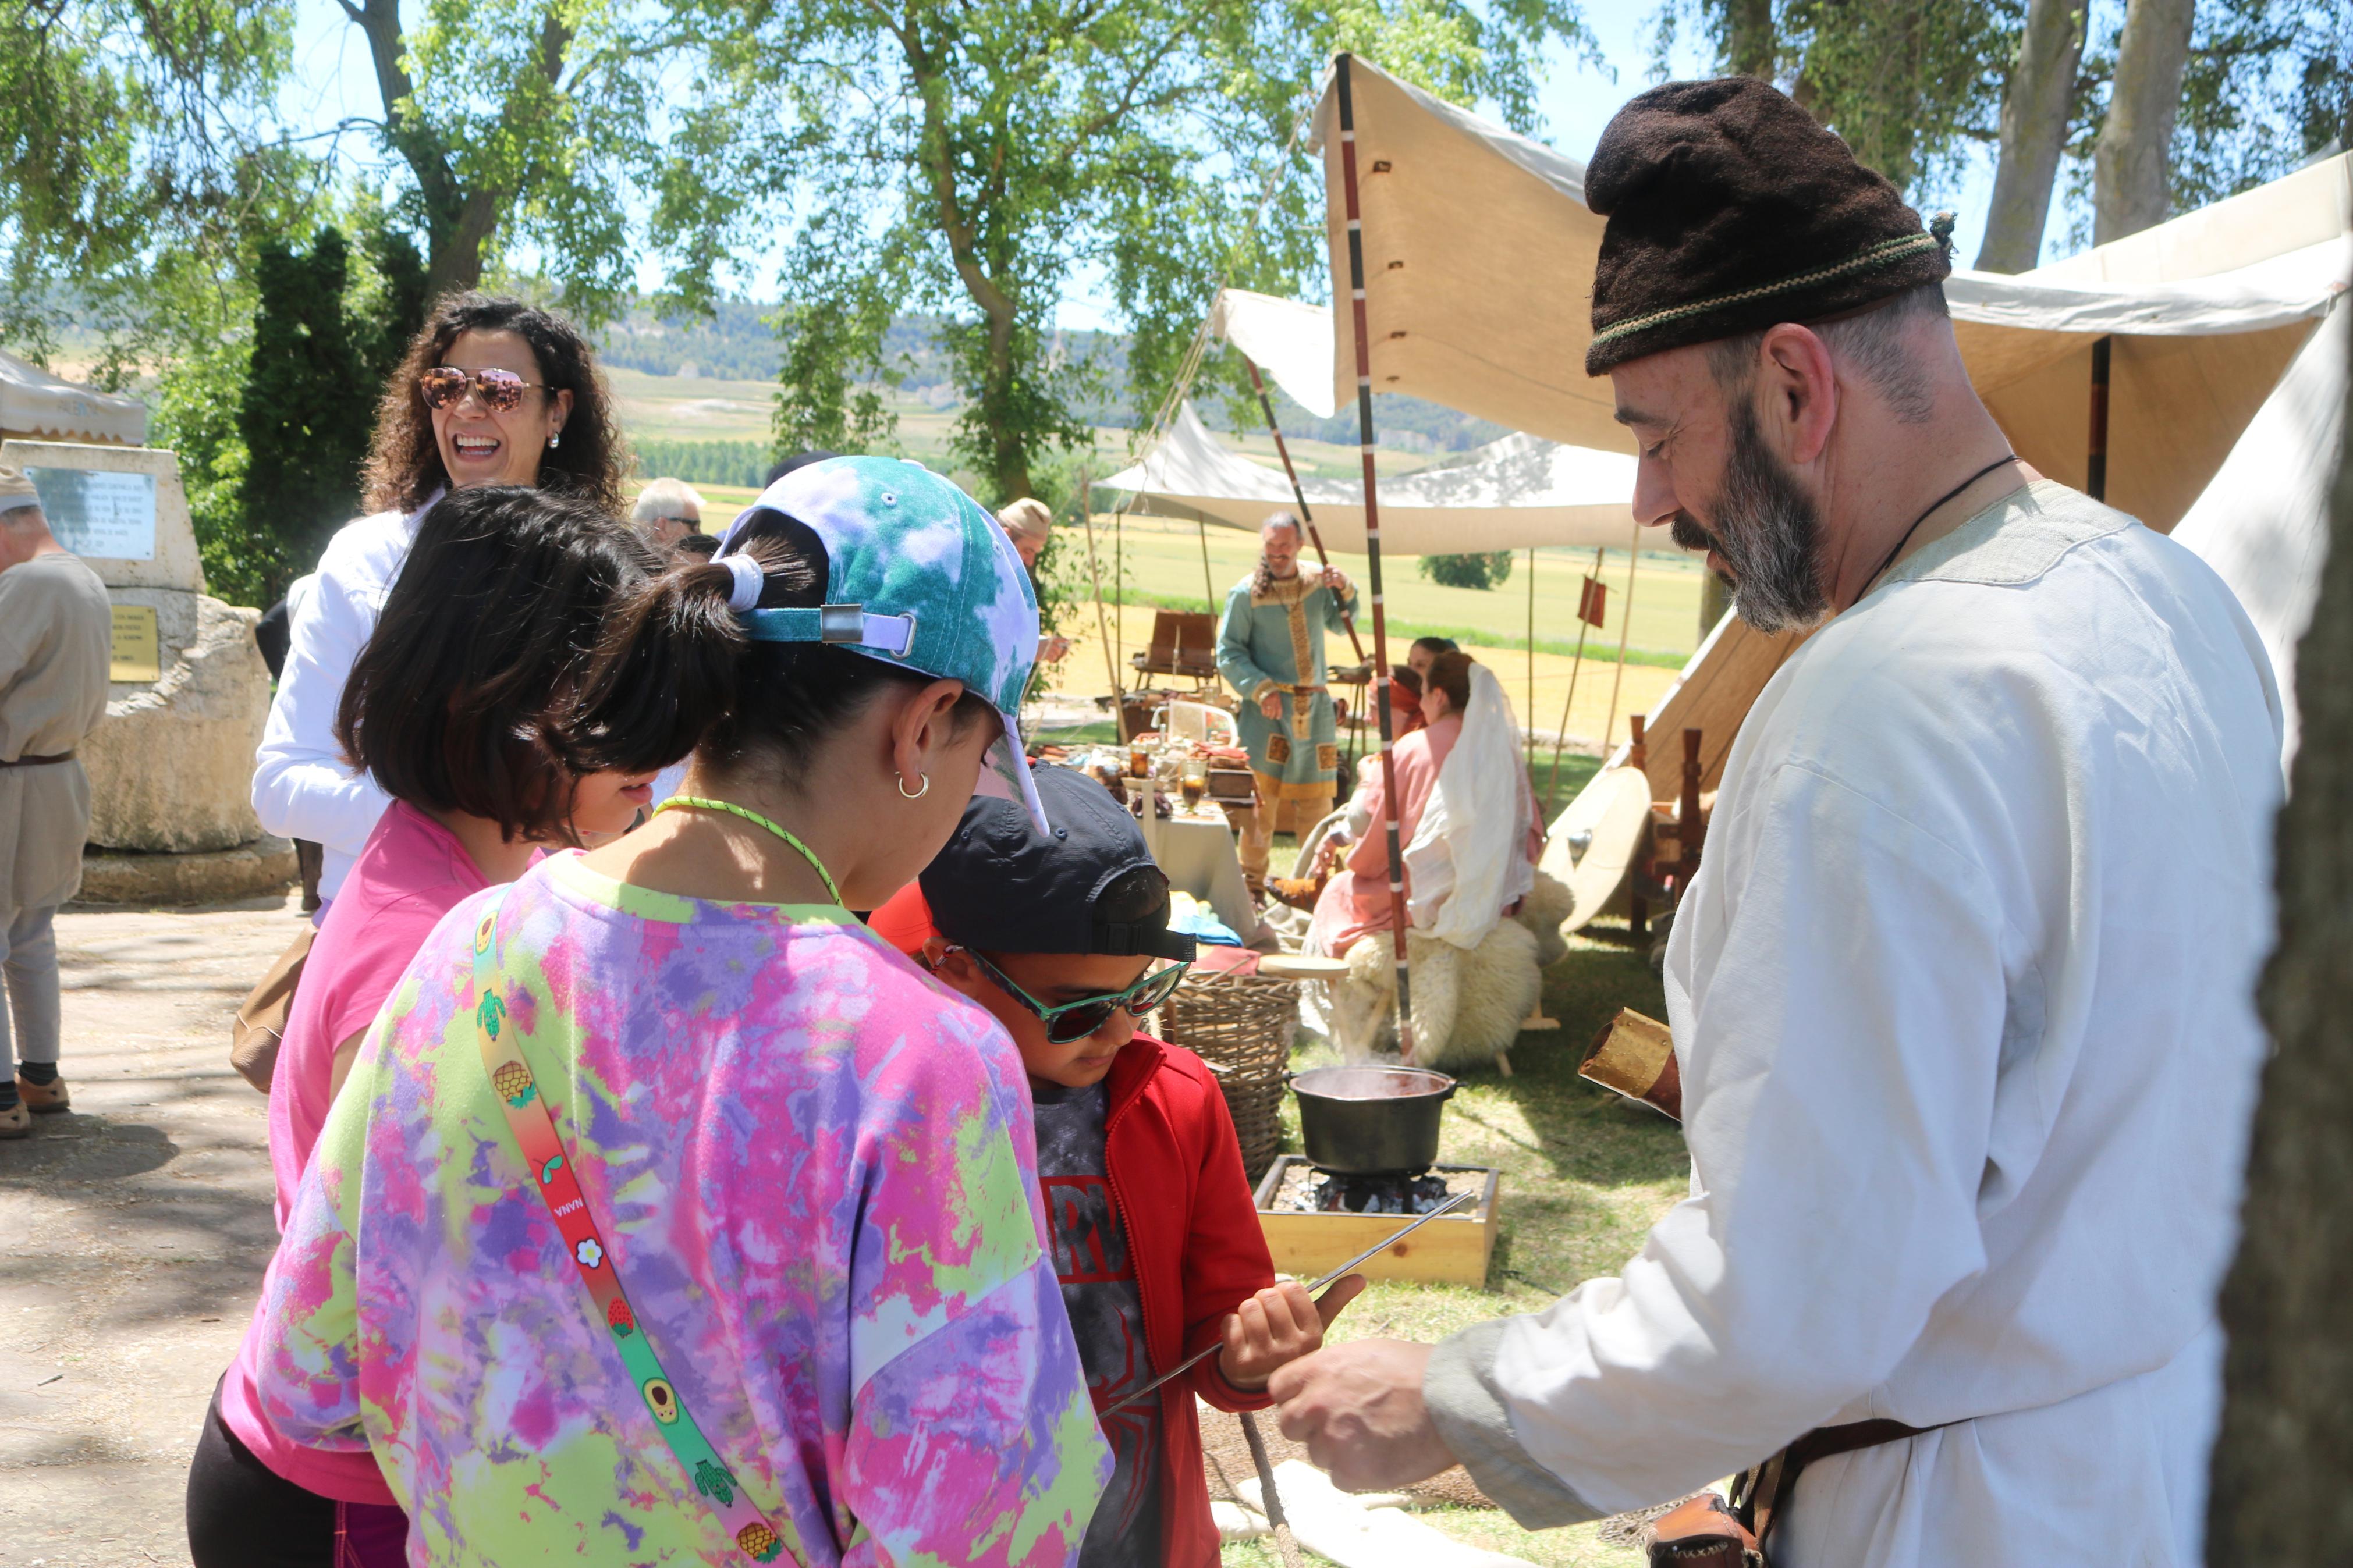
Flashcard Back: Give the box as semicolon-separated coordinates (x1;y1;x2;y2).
259;854;1110;1568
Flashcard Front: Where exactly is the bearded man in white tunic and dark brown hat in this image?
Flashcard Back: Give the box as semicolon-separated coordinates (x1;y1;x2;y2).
1273;80;2280;1568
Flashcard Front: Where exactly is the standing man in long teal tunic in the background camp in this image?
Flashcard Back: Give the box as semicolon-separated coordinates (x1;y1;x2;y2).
1216;513;1355;886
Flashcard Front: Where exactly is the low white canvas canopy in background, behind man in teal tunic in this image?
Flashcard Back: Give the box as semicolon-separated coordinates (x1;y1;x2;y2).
1101;401;1633;555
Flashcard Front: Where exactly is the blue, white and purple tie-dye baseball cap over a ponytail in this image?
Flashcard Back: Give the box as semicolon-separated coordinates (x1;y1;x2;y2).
718;458;1052;832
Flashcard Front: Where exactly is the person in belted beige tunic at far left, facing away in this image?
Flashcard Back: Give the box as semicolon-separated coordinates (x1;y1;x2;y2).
0;468;113;1138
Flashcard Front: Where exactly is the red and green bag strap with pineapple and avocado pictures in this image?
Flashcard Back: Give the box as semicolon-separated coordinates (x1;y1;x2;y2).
473;888;800;1568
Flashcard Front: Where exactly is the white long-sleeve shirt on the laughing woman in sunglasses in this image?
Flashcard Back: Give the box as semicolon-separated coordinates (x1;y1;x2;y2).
254;494;438;898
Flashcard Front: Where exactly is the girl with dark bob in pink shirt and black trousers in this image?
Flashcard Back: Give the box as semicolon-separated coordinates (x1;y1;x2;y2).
188;486;659;1568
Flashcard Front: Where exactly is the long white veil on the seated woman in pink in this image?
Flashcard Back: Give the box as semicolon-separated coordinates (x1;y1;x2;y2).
1405;663;1536;950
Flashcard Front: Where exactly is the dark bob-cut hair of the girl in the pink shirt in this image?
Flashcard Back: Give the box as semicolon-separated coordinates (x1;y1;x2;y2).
334;484;661;841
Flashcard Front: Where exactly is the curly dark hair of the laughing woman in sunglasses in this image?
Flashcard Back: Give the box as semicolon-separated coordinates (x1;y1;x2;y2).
367;291;628;515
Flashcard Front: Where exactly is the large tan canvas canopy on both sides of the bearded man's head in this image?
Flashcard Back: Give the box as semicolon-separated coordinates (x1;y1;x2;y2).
1318;59;2353;529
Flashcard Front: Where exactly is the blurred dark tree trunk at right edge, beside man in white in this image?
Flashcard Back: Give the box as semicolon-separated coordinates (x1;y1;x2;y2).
2207;305;2353;1568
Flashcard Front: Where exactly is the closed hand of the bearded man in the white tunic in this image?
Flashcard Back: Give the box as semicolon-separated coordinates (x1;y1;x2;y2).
1266;1340;1454;1493
